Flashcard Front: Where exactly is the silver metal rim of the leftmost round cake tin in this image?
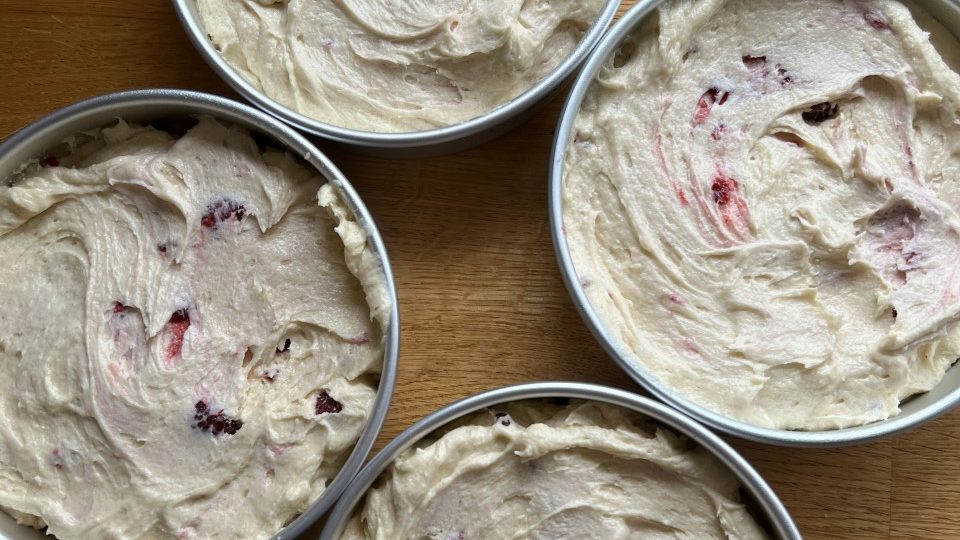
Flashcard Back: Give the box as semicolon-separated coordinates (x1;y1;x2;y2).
0;89;400;540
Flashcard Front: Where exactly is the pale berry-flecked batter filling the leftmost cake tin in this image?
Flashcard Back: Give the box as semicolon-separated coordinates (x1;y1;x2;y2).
0;118;389;540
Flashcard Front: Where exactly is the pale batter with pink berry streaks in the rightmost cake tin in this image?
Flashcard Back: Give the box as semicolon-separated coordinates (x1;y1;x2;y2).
563;0;960;430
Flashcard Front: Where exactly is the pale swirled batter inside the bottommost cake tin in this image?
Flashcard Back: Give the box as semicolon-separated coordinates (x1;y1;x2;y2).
341;400;766;540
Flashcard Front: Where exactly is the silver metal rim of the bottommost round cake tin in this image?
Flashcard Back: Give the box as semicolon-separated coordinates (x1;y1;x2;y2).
320;382;800;540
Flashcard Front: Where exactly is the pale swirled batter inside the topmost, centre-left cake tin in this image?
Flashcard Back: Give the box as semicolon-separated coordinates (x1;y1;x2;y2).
197;0;603;132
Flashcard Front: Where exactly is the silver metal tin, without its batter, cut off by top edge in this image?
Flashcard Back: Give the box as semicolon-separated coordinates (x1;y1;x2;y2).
173;0;620;157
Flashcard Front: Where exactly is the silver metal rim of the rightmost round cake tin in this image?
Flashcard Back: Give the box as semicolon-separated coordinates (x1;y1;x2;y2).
549;0;960;447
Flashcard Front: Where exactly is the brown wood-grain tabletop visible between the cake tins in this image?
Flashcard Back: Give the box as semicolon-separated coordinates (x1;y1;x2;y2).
0;0;960;539
